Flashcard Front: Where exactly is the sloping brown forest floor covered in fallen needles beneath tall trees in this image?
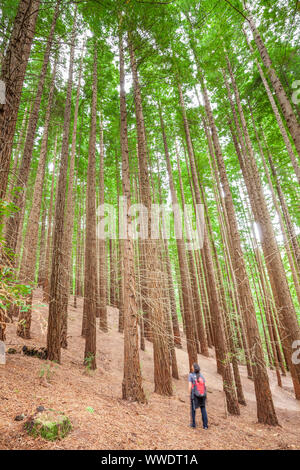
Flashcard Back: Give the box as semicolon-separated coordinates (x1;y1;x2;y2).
0;289;300;450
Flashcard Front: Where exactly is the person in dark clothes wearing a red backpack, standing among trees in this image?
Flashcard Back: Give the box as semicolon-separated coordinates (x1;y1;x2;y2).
189;363;208;429
